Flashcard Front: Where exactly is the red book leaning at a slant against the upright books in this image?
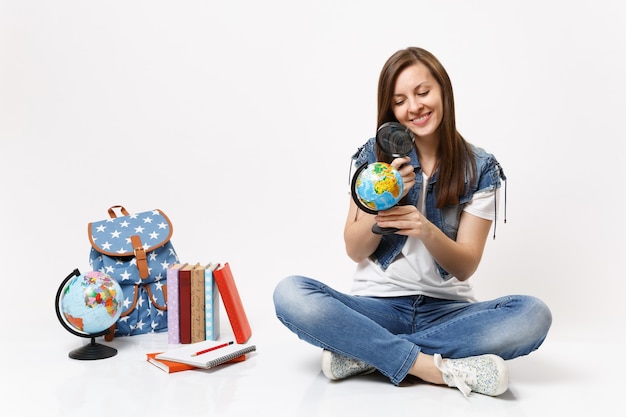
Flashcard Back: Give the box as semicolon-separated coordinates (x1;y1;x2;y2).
213;262;252;344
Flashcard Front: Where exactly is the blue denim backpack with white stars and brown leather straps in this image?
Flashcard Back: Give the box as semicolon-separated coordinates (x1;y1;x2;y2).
88;206;178;341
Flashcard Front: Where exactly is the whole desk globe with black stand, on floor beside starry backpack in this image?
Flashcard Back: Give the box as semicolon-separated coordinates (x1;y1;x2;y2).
55;269;123;360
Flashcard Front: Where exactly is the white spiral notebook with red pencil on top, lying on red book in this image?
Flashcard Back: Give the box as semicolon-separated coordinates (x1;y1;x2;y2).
155;340;256;369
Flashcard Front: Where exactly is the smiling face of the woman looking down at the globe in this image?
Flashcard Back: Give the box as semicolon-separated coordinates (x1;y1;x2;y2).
391;62;443;139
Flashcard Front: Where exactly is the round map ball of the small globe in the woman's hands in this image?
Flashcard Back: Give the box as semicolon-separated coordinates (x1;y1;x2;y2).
353;162;404;214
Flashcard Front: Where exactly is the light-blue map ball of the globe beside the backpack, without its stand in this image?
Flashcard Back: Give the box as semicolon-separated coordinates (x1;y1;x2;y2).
60;271;123;334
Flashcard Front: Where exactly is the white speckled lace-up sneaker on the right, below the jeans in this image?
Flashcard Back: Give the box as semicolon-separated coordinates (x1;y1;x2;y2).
435;354;509;397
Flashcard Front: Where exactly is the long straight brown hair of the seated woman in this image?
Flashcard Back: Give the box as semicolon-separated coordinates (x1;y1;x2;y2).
376;47;476;208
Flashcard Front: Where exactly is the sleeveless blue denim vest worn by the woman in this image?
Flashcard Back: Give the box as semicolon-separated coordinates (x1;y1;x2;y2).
352;138;506;279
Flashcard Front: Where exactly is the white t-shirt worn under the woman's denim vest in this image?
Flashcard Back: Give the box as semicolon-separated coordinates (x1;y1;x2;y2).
351;175;499;301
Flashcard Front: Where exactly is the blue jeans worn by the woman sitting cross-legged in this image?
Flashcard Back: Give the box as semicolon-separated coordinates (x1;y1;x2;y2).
274;276;552;385
